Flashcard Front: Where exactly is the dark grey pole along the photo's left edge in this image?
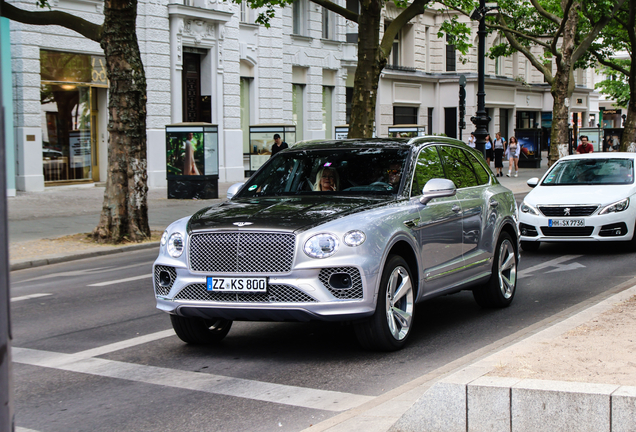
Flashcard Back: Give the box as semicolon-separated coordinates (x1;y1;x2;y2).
0;4;14;431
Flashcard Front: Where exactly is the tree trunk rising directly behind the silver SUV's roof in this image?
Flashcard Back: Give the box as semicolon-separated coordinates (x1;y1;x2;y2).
348;1;386;138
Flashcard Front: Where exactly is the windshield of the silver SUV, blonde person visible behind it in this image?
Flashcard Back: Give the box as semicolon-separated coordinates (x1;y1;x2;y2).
237;148;409;198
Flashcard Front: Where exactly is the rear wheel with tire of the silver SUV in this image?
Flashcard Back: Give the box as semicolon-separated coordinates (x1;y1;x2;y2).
473;232;518;308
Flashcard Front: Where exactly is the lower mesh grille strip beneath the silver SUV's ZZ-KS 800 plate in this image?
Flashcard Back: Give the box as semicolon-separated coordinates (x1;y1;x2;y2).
174;284;316;303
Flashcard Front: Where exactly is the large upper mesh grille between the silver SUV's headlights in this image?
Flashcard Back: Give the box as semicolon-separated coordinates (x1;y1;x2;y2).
190;232;296;273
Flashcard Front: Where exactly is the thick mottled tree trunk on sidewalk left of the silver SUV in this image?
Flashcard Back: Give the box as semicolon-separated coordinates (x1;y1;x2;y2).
93;0;150;243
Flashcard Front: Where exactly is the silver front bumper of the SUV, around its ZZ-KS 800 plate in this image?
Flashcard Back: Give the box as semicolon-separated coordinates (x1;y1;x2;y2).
153;258;378;321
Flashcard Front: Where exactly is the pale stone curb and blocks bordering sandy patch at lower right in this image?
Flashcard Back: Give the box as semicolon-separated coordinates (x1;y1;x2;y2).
390;280;636;432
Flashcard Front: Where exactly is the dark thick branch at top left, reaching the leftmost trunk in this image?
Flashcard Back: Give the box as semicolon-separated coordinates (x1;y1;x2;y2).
0;0;102;42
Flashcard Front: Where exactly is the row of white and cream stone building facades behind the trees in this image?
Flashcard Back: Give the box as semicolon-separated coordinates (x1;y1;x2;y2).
6;0;599;191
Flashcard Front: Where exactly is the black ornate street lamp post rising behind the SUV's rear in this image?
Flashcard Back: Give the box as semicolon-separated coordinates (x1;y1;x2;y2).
470;0;498;156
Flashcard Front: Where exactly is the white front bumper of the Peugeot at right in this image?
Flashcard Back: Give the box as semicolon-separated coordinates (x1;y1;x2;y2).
519;212;634;242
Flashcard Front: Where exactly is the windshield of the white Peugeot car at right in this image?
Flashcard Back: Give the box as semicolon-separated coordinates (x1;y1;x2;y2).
541;158;634;186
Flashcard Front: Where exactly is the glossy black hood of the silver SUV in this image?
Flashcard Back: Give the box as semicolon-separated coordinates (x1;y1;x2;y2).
188;197;395;232
